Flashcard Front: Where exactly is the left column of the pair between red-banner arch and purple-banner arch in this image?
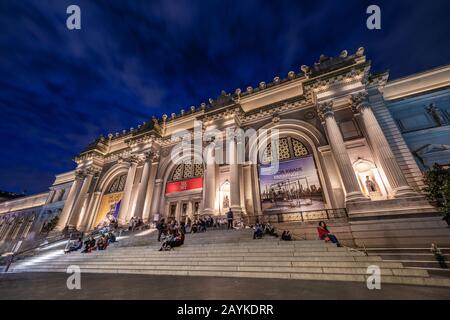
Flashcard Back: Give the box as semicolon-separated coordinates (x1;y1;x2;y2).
203;142;216;215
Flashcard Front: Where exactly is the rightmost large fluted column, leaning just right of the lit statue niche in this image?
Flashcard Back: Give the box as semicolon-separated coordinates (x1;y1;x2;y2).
351;93;417;197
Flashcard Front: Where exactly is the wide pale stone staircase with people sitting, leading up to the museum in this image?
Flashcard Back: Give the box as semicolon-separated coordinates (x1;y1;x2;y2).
6;229;450;287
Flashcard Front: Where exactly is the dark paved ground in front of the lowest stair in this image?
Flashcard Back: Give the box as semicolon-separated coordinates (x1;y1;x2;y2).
0;273;450;300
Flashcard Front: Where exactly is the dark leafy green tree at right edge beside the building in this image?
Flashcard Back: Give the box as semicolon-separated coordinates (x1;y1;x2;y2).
424;163;450;223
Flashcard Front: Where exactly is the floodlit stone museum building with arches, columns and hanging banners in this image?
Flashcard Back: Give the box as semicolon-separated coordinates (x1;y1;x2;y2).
0;48;450;251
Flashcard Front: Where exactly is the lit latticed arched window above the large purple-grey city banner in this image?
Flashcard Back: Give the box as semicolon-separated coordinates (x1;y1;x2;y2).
262;137;310;163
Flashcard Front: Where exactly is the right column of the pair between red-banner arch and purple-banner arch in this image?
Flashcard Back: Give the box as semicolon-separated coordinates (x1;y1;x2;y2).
232;138;242;214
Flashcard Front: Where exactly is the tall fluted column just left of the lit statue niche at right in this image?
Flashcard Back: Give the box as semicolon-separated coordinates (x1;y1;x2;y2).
317;101;368;202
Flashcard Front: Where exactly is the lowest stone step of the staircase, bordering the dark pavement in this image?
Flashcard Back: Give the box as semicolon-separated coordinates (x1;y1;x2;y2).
10;268;450;287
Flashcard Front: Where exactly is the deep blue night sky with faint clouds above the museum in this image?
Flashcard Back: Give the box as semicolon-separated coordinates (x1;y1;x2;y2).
0;0;450;193
